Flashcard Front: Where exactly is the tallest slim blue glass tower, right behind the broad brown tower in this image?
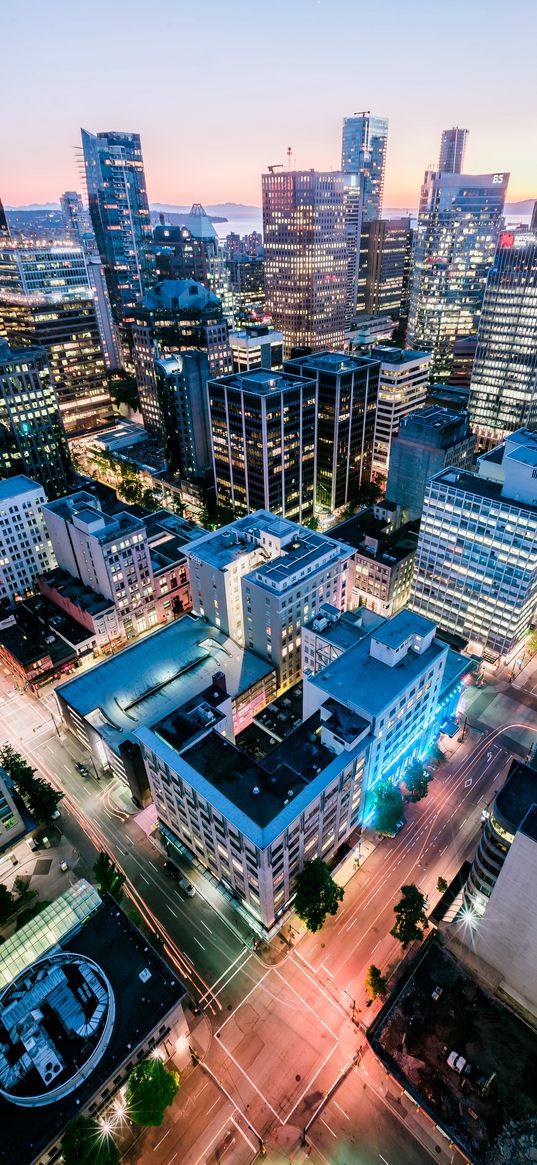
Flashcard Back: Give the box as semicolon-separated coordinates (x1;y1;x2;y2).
341;112;388;329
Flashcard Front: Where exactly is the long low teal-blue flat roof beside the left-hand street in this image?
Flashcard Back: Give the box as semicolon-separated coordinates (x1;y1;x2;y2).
56;615;273;741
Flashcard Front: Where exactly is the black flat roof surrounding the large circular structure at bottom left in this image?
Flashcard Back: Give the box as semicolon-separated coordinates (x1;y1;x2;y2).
0;896;186;1165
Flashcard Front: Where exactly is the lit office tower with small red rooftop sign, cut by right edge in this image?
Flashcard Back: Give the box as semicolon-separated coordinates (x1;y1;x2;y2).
469;230;537;445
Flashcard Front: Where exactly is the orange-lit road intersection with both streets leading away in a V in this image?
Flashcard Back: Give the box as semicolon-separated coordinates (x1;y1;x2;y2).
0;669;537;1165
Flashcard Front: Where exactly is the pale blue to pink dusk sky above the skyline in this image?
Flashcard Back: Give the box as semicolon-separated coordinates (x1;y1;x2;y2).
0;0;537;209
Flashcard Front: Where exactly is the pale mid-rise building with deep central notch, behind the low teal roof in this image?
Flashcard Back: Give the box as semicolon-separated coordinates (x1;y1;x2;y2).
188;510;353;689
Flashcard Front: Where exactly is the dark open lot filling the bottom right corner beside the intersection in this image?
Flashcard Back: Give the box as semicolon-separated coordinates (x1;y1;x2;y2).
370;938;537;1165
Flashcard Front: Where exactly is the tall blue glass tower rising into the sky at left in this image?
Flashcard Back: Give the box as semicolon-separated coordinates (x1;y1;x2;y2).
82;129;156;324
